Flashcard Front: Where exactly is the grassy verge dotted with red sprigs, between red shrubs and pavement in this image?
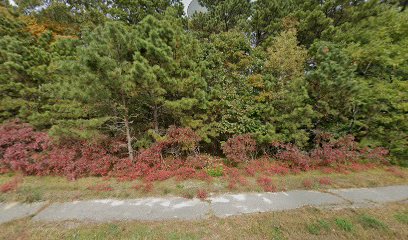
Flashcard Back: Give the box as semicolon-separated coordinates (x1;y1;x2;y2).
0;167;408;203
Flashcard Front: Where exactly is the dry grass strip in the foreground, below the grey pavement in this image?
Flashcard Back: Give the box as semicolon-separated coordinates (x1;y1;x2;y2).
0;203;408;240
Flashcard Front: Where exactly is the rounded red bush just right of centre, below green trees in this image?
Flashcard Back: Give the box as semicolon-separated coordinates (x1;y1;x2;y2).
222;134;256;164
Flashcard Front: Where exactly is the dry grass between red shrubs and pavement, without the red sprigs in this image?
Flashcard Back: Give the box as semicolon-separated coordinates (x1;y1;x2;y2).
0;168;408;202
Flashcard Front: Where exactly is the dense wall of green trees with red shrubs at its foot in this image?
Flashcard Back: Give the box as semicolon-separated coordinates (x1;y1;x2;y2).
0;0;408;180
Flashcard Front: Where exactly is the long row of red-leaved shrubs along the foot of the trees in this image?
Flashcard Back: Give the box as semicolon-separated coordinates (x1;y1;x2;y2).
0;121;394;188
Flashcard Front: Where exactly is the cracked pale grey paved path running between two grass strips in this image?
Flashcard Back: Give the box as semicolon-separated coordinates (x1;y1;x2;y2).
0;185;408;224
